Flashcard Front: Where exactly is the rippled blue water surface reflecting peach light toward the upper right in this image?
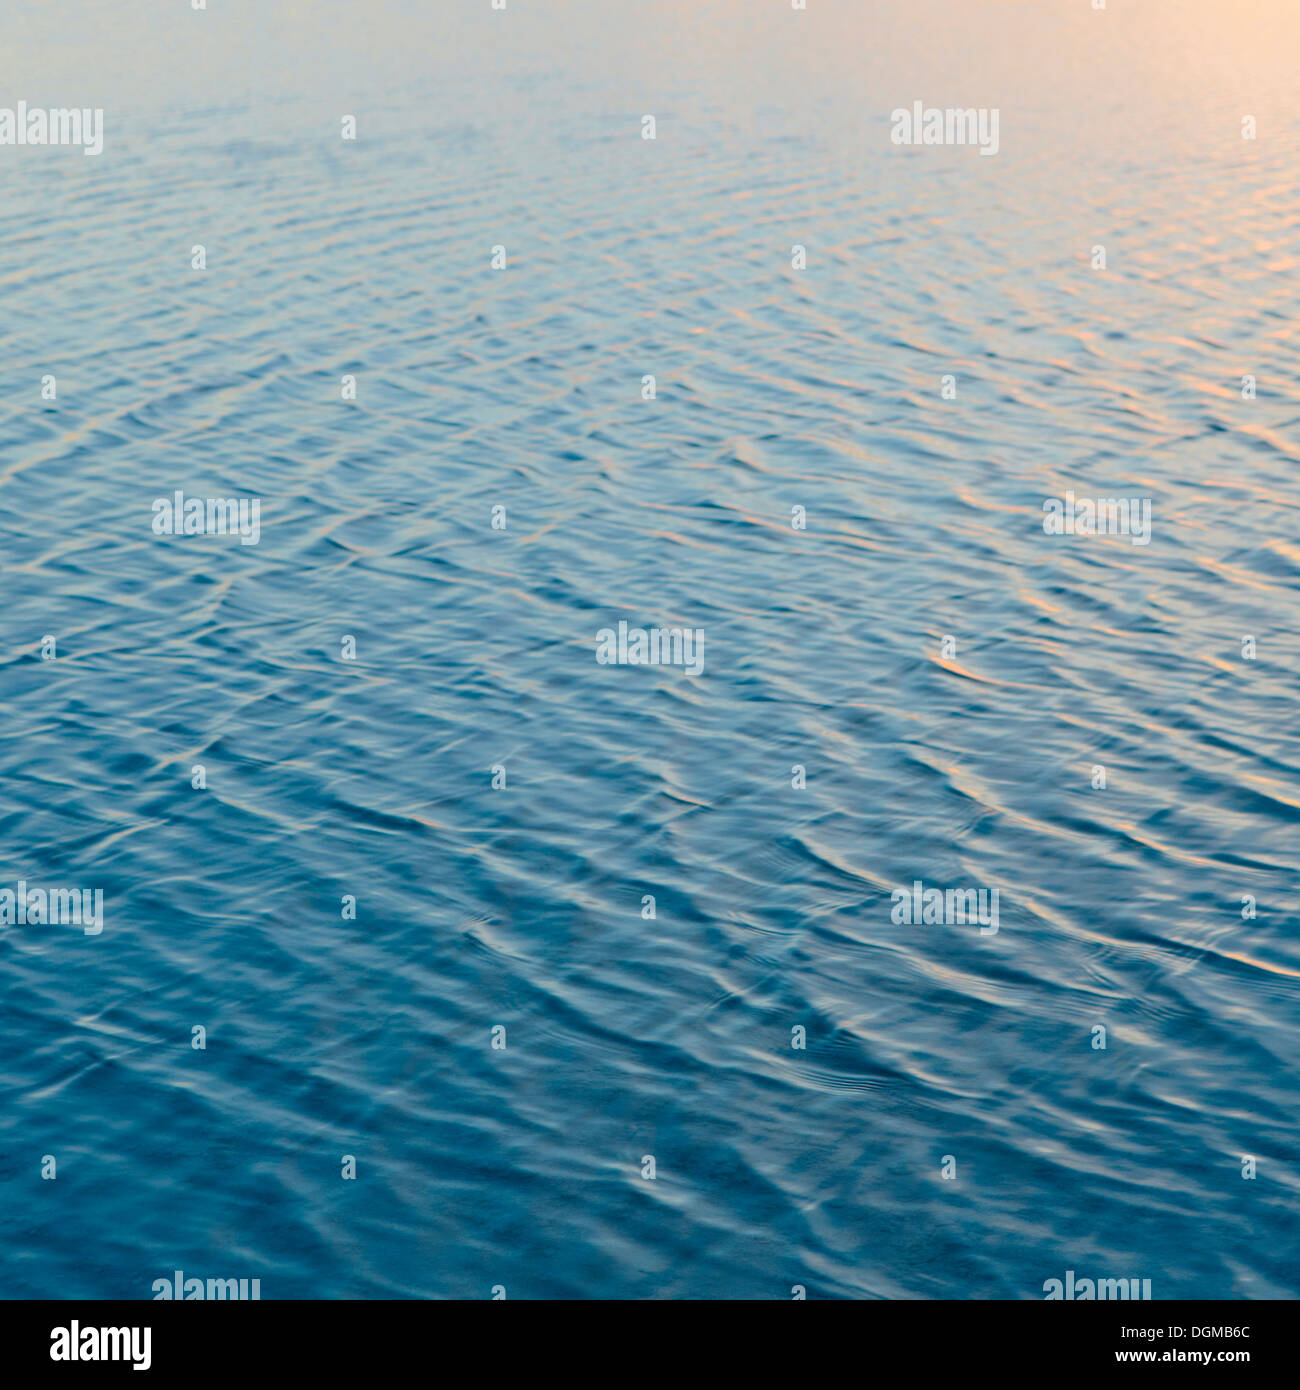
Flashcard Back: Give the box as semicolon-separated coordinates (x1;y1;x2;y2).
0;0;1300;1298
